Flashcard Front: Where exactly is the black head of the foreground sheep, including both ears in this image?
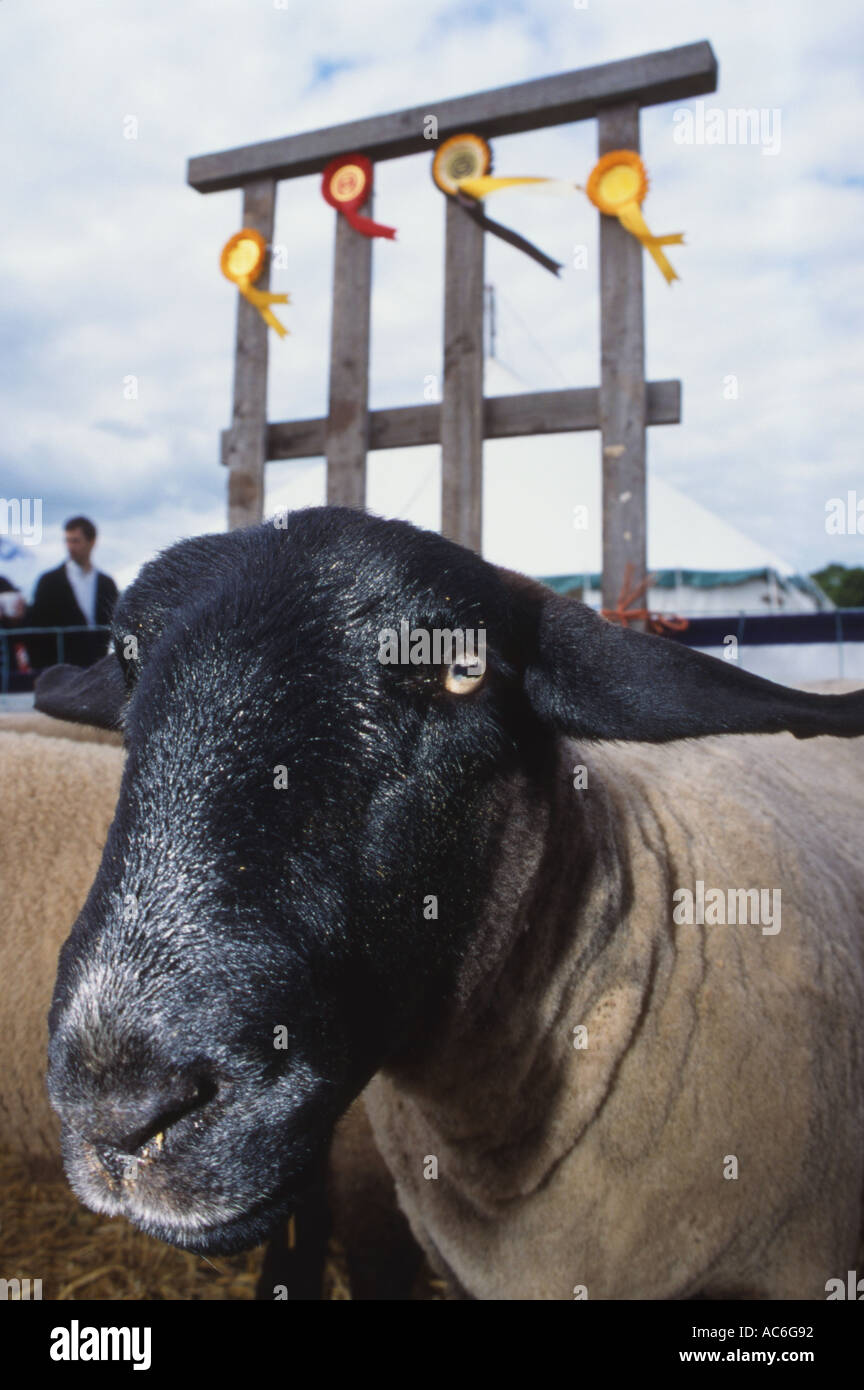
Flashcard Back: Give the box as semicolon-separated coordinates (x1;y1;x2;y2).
38;507;864;1251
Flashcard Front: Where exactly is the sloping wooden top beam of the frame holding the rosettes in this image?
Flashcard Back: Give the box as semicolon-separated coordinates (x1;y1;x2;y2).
188;40;717;193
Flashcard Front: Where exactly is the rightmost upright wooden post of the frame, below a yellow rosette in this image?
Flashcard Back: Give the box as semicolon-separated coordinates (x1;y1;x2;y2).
597;104;647;627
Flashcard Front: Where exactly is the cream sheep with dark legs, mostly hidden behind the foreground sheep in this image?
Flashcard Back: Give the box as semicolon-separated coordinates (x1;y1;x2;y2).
0;712;415;1298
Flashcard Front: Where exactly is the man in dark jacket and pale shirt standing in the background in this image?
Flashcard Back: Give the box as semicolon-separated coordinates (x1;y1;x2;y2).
24;517;117;667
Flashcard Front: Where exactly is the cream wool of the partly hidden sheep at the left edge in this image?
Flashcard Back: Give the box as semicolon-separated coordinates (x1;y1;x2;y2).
0;720;124;1163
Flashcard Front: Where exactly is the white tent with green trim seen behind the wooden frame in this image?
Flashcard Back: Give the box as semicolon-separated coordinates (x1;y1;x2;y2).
267;434;832;616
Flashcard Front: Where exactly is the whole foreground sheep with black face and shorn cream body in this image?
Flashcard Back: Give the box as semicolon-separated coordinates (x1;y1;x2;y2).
38;509;864;1298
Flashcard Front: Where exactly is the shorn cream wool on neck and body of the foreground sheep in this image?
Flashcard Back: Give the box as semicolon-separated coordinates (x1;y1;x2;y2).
365;728;864;1300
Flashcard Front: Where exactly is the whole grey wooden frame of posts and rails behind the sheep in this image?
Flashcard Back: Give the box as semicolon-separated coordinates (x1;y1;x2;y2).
188;42;717;607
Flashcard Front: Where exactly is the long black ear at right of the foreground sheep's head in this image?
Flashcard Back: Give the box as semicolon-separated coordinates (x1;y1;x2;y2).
503;573;864;744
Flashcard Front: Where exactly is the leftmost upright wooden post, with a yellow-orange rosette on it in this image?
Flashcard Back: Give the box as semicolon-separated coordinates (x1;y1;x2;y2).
224;178;276;531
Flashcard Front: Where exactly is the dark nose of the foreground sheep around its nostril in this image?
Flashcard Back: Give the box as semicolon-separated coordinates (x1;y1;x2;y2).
89;1072;217;1177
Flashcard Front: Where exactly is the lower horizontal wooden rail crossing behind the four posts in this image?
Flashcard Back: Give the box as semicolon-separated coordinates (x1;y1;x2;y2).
261;381;681;463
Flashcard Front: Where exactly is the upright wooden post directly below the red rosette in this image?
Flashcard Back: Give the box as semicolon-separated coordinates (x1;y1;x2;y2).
325;200;372;507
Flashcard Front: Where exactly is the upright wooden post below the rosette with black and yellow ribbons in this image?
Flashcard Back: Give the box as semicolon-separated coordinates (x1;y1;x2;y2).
440;197;485;555
